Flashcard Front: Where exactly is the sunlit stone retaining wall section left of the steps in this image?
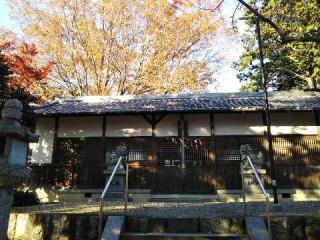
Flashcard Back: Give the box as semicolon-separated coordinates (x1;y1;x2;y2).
8;214;98;240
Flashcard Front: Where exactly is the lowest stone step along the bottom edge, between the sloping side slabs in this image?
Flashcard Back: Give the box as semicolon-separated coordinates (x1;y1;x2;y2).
120;232;246;240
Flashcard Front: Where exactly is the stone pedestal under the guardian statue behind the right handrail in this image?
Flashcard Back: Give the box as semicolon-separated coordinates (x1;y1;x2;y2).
243;168;267;194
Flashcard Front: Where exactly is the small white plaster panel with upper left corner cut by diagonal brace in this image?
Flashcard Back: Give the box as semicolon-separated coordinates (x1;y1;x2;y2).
156;114;180;137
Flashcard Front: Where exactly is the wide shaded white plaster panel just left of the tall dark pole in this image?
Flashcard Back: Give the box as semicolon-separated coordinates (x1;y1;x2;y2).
214;112;264;135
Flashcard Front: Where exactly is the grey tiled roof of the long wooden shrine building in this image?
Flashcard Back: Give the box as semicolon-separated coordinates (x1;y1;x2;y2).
35;92;320;115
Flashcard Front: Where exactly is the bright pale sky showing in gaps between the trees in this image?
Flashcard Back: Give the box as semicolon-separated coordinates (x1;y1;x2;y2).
0;0;244;92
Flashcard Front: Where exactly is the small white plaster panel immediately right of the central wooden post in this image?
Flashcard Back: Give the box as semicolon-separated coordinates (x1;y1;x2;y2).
185;114;211;136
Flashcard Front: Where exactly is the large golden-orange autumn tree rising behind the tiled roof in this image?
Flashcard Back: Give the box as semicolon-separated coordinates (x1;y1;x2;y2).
10;0;223;95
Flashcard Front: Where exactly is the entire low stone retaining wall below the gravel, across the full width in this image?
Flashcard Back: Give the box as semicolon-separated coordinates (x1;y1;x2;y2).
8;214;320;240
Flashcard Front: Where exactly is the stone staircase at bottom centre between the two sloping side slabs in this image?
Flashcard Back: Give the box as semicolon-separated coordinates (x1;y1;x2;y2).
120;217;246;240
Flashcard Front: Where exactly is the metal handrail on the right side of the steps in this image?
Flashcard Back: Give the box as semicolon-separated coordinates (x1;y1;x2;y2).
241;155;272;240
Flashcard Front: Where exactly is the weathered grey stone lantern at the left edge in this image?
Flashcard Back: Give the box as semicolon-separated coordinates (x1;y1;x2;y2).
0;99;39;239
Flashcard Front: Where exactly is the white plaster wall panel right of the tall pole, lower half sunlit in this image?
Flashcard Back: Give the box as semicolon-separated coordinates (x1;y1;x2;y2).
270;112;318;135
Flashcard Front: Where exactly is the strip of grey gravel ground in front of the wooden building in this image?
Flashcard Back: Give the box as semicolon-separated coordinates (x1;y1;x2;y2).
12;201;320;218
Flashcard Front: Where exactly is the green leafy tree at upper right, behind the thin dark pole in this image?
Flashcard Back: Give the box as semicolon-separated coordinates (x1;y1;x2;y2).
235;0;320;91
